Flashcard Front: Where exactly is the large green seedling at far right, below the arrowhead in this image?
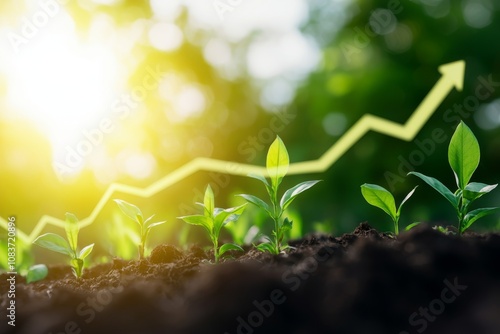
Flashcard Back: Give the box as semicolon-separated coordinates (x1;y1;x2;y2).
408;122;498;234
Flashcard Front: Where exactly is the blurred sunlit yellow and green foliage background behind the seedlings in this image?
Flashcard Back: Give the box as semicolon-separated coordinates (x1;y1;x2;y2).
0;0;500;268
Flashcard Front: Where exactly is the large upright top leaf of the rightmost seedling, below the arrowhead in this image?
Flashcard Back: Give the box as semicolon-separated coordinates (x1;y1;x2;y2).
448;122;481;190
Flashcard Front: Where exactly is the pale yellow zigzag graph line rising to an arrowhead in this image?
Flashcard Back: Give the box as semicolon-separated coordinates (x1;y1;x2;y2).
0;60;465;243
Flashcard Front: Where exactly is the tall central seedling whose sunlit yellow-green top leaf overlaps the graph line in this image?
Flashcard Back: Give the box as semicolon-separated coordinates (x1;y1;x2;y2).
239;136;320;254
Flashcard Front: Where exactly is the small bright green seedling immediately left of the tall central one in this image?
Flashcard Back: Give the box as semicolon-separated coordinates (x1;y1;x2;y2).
178;185;246;263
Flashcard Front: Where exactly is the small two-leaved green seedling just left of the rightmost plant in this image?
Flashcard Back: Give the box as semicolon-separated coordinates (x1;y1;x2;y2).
361;183;417;235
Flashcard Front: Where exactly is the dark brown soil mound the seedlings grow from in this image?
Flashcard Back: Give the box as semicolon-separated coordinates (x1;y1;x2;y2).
0;224;500;334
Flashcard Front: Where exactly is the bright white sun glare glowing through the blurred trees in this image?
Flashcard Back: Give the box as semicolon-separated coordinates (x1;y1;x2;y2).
7;11;123;172
